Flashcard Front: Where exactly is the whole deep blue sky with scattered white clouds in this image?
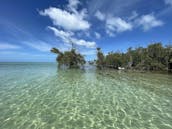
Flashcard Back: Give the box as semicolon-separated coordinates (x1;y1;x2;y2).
0;0;172;62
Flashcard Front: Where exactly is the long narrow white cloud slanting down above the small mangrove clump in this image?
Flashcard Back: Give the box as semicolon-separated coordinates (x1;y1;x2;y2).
48;27;96;48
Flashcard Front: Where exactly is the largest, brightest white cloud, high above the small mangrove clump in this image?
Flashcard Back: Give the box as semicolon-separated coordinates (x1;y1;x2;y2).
40;7;91;31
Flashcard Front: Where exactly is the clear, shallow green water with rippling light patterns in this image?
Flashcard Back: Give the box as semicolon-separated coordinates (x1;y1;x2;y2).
0;63;172;129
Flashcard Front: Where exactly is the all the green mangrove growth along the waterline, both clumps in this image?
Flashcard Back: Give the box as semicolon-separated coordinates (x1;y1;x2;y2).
51;43;172;72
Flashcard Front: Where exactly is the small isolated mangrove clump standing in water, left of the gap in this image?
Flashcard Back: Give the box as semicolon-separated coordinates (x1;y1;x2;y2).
51;48;85;68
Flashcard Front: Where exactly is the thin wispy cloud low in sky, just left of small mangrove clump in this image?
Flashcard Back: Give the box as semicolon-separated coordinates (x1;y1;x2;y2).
22;41;52;52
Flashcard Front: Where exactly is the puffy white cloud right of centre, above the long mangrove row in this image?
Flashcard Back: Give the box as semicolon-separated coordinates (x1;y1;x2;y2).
106;17;133;36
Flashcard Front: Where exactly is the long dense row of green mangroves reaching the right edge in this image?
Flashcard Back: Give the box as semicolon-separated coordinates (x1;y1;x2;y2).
97;43;172;70
